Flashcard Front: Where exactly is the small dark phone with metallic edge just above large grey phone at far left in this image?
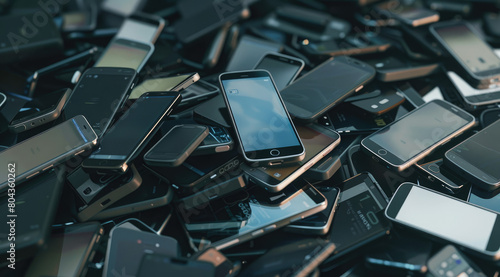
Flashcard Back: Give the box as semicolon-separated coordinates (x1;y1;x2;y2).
9;88;71;133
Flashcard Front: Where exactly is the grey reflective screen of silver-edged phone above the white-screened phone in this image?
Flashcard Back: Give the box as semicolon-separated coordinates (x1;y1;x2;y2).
368;102;468;161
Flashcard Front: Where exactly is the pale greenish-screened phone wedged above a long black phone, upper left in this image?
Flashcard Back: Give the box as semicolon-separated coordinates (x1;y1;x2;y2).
94;38;154;72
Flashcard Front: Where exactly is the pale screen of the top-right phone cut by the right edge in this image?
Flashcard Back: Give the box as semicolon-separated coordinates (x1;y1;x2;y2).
435;25;500;72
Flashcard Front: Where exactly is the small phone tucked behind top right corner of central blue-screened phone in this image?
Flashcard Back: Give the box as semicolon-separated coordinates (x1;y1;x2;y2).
254;53;304;91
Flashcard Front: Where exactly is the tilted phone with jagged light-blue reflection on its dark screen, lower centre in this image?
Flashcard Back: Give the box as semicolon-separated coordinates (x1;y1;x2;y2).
179;179;327;250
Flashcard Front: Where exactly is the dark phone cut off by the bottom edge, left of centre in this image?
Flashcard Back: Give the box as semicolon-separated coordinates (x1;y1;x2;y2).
135;253;215;277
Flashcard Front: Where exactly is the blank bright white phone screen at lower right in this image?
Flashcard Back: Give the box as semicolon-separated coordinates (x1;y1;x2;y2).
396;187;496;250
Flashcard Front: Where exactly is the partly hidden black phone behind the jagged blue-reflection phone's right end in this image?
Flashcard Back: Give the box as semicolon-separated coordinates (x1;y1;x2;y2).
285;184;340;235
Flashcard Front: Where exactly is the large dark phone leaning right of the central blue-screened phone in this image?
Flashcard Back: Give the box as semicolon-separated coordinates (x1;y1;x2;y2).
281;56;375;121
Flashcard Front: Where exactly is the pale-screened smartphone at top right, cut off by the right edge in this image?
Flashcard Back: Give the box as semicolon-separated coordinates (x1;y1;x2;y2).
429;21;500;88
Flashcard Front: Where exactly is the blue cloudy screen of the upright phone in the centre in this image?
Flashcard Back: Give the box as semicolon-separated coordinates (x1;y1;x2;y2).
222;77;300;152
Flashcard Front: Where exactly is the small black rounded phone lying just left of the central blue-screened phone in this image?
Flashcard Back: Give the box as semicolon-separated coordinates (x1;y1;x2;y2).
144;124;208;167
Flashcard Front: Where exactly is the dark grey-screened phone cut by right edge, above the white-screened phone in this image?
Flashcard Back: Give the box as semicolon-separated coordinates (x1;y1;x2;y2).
444;117;500;191
